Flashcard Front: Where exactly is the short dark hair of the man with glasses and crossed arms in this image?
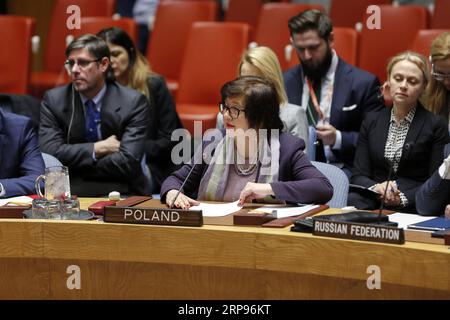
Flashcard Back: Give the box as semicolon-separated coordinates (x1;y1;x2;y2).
66;34;115;82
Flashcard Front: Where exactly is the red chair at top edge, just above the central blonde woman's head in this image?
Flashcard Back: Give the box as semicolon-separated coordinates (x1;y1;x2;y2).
225;0;263;39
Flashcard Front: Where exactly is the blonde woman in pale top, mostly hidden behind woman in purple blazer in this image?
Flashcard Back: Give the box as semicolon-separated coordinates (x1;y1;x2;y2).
217;47;308;152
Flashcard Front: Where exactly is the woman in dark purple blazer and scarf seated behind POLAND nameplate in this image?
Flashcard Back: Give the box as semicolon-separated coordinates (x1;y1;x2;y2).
161;77;333;209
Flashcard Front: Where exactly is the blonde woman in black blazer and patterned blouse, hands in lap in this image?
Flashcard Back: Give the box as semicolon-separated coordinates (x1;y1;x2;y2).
348;52;449;212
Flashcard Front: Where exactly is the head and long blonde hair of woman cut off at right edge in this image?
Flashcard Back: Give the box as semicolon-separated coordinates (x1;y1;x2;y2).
425;32;450;131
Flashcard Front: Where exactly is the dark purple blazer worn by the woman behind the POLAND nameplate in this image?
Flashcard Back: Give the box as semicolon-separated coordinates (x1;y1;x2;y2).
161;133;333;204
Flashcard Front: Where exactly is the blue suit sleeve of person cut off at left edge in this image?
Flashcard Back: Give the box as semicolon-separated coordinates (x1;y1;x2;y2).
0;109;45;198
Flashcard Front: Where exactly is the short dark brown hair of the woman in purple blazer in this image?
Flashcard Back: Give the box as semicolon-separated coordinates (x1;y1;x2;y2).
220;76;283;130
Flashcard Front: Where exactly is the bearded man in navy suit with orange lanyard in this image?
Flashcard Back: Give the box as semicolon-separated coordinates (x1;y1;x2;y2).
283;10;383;176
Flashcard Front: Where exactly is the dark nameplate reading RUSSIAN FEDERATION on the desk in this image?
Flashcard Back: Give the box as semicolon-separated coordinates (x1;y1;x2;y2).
313;218;405;244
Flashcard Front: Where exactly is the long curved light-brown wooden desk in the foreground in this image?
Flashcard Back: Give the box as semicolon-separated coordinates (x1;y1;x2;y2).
0;199;450;299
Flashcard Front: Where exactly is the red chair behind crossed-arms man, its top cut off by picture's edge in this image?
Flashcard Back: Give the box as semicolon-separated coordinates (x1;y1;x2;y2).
31;0;116;97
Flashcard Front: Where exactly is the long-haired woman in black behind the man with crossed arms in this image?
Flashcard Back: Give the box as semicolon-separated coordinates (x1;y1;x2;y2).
98;27;182;192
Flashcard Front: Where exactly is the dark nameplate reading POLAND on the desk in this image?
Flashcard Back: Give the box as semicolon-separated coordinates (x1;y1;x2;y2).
103;207;203;227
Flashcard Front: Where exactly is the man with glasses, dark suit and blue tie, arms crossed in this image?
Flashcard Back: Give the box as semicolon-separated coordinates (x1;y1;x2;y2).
39;35;151;196
